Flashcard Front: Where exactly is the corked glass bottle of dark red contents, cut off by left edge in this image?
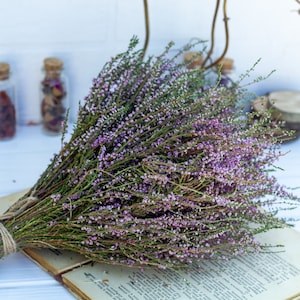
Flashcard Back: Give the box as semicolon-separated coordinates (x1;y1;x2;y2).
0;63;17;140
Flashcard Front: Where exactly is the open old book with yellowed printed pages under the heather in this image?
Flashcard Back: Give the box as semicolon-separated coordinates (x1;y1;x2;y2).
0;193;300;300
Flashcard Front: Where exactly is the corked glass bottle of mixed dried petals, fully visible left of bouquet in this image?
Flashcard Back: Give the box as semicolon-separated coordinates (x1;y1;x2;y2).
41;57;67;135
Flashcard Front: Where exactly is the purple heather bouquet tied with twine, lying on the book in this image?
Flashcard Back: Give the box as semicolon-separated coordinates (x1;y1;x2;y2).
0;39;297;268
